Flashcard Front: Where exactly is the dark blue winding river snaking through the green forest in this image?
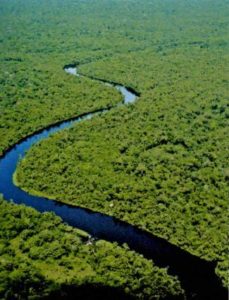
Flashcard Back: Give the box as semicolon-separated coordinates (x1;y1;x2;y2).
0;65;227;300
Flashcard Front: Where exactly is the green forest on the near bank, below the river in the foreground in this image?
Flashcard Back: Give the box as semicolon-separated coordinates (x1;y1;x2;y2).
0;199;182;299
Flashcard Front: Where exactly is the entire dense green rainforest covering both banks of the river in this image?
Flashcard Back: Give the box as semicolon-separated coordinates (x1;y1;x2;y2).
0;0;229;299
